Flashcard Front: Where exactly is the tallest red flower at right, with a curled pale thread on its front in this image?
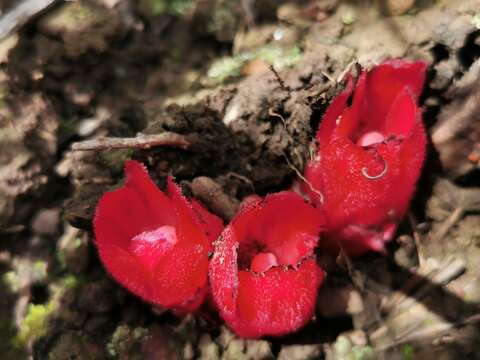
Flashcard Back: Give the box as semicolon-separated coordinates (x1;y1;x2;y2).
303;60;427;255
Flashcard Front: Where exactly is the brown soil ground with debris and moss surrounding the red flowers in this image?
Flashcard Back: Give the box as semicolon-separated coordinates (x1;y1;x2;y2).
0;0;480;360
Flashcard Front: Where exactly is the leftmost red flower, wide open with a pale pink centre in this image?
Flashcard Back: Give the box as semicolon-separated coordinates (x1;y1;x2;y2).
94;161;223;311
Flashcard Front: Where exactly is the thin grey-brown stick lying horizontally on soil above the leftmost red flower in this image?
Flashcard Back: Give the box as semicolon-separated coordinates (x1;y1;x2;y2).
72;132;192;151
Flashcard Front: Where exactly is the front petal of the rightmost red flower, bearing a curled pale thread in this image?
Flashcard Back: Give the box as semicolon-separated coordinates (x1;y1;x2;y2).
303;114;426;255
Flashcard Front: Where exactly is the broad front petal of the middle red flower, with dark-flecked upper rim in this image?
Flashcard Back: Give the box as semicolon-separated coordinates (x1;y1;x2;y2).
221;260;324;338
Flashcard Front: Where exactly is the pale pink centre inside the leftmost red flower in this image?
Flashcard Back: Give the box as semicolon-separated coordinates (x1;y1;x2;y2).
130;225;177;270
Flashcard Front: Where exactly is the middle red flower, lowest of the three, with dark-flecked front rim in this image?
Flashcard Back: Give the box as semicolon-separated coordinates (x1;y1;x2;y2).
209;192;324;338
